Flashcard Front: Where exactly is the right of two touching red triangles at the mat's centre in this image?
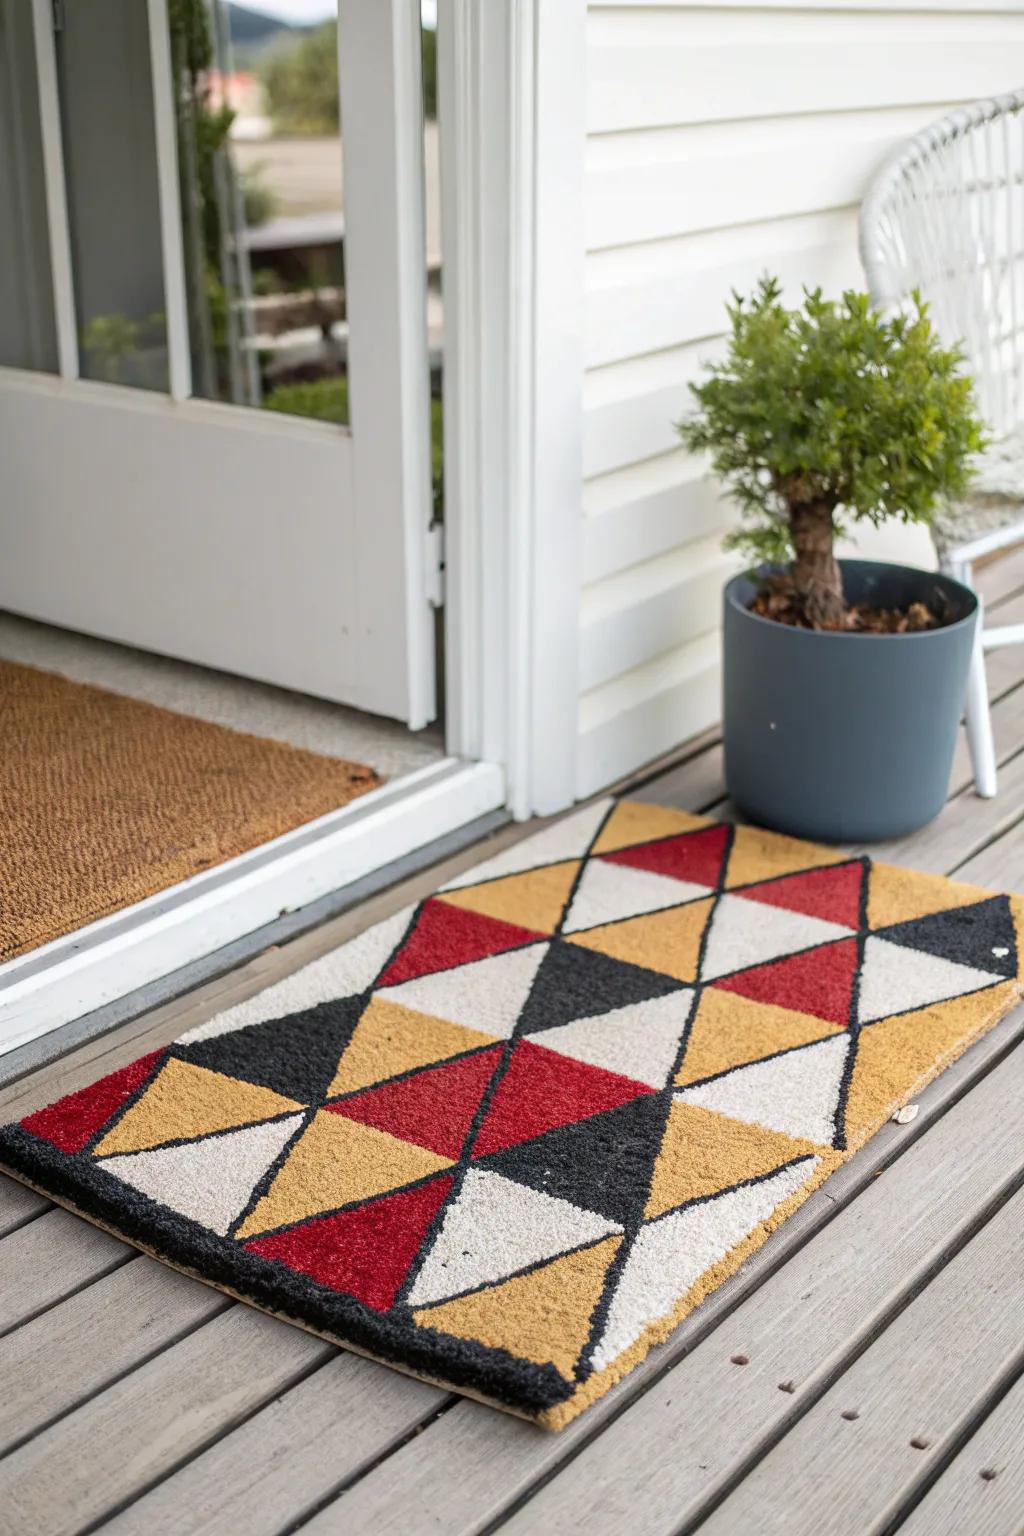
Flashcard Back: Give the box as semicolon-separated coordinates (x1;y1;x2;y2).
473;1037;652;1157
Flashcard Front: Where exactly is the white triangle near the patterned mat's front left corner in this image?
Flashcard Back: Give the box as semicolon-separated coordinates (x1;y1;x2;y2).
97;1115;302;1236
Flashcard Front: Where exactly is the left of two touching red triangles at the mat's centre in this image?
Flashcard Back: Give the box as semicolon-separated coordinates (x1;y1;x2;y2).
324;1046;504;1160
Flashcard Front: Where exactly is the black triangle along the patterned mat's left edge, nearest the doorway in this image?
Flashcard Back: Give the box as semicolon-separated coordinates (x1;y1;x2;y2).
173;992;367;1104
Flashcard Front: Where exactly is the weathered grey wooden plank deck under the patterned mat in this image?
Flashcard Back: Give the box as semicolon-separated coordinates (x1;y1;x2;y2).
0;558;1024;1536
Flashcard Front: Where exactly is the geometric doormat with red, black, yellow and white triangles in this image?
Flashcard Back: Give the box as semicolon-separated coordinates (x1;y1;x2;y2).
0;800;1024;1428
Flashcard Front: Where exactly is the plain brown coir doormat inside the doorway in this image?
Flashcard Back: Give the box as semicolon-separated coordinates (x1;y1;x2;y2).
0;660;379;960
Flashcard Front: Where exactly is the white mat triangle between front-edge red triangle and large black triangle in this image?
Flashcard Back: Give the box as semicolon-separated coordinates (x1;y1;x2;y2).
408;1167;622;1307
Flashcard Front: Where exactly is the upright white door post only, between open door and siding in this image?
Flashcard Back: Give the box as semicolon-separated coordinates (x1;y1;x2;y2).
438;0;586;819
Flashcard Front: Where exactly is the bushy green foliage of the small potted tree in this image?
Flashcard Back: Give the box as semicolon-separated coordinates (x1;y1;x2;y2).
679;278;986;562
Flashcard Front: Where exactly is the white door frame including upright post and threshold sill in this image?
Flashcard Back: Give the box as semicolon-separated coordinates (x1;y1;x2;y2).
0;0;586;1055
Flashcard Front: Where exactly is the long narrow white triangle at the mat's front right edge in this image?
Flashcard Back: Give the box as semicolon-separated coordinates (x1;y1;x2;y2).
593;1157;820;1370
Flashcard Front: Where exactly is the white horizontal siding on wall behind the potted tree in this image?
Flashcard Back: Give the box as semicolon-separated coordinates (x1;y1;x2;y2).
579;0;1024;794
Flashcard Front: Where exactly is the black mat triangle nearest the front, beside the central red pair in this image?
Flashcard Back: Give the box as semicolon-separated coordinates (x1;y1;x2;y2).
479;1094;669;1226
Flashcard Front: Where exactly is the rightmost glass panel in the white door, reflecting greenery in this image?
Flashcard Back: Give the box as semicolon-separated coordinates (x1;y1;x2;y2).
170;0;348;424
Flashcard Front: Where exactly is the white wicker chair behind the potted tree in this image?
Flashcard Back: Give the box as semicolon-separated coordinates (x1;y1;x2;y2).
860;91;1024;796
